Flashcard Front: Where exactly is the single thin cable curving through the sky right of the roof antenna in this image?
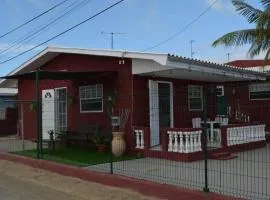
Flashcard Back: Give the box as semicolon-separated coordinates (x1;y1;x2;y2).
141;0;218;52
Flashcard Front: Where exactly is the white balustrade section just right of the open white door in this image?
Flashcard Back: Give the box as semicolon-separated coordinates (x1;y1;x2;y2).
167;131;202;153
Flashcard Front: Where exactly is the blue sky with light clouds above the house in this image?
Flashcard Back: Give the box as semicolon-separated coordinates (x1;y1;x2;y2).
0;0;263;76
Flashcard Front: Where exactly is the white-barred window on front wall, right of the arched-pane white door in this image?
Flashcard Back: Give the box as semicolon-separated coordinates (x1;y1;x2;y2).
80;84;103;112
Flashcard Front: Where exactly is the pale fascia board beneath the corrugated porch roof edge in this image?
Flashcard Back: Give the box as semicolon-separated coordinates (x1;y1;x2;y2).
167;61;266;80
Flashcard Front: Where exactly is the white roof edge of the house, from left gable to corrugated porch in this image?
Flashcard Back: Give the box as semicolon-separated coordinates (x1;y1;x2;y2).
0;47;265;87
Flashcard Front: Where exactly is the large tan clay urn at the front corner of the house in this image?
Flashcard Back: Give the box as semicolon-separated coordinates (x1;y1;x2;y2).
112;132;126;157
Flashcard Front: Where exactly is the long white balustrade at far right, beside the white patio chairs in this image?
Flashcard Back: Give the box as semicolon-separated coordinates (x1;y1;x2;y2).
227;124;266;146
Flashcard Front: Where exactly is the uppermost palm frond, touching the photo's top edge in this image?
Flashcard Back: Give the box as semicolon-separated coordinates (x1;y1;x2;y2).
232;0;262;23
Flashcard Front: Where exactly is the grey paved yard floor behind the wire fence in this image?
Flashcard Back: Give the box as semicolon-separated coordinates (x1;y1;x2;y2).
87;144;270;199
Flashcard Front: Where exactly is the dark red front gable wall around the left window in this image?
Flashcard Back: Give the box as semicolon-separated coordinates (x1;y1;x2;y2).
18;54;132;140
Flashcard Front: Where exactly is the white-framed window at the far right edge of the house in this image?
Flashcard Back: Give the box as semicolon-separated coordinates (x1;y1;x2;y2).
249;83;270;100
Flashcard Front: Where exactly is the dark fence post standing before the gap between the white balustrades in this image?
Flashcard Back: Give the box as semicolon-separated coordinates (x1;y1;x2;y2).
203;86;210;192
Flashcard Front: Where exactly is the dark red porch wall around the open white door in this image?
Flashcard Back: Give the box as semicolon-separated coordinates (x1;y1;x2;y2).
133;76;215;128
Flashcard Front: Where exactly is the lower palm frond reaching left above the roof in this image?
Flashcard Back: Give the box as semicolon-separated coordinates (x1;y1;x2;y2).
212;29;257;47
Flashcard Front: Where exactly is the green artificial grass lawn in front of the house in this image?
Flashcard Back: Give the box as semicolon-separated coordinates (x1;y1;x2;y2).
13;148;141;167
